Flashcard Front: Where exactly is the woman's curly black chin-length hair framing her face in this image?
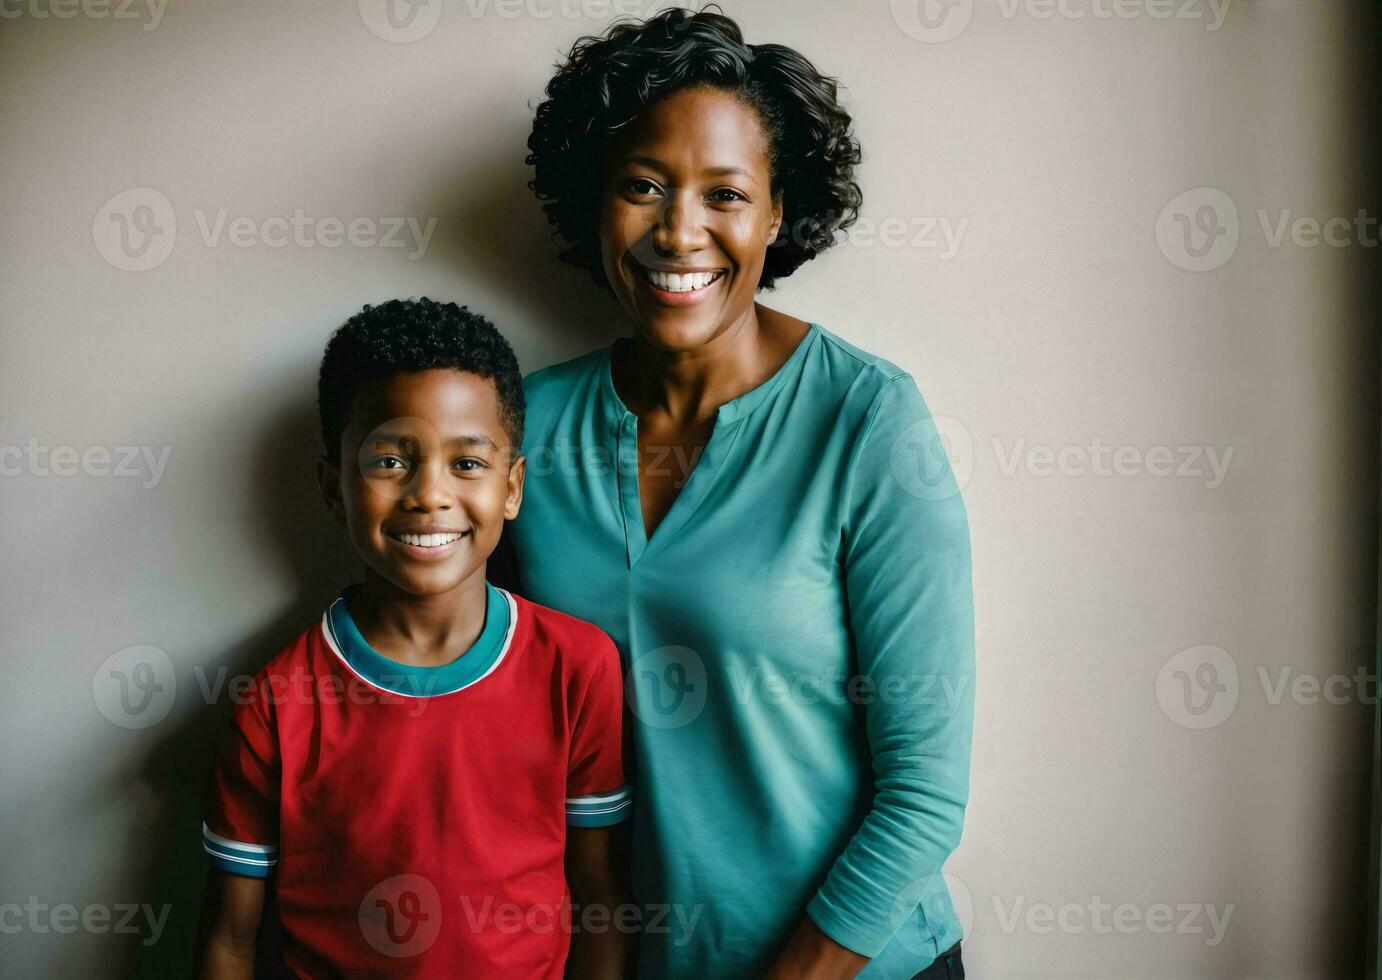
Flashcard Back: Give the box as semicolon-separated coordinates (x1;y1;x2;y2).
525;7;862;289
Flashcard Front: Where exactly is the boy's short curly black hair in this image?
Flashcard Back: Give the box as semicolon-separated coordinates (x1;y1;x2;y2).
316;296;524;463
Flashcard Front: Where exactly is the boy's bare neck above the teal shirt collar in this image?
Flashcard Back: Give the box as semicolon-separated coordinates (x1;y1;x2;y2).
346;565;489;668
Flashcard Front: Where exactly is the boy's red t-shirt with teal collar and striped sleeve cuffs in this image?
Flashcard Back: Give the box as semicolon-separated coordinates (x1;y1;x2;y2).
203;583;632;980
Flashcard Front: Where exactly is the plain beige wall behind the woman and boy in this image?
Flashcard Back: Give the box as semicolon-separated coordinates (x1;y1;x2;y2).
0;0;1378;980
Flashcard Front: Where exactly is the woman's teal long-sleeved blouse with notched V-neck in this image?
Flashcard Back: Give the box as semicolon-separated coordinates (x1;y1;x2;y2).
507;323;974;980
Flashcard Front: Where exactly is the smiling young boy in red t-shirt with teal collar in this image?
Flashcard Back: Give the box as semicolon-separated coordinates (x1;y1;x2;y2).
200;299;632;980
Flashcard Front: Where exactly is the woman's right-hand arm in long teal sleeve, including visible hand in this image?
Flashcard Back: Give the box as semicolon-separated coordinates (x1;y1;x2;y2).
774;375;974;977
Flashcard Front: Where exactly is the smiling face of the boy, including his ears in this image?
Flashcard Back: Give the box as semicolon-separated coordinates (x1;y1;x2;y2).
318;368;525;596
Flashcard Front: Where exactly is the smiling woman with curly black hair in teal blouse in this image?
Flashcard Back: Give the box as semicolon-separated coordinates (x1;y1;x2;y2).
507;10;973;980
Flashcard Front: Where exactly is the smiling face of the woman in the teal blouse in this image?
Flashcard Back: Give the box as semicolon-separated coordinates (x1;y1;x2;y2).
600;87;782;351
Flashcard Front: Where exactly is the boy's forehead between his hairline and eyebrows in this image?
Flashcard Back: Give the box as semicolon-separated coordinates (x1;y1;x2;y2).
347;368;507;445
